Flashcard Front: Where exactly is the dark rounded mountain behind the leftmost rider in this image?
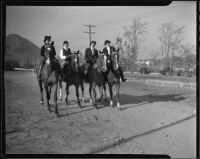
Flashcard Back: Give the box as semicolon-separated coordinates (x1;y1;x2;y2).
5;34;40;66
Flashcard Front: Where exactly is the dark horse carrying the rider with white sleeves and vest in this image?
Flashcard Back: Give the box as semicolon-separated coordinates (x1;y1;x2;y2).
59;50;84;108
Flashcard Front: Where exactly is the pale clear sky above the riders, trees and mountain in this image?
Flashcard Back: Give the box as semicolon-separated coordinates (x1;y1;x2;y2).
6;1;196;59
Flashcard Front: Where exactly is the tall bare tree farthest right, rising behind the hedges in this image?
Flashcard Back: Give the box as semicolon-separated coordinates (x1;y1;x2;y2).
159;22;184;67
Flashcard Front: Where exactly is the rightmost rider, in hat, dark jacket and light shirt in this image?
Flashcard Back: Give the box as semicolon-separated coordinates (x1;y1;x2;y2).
102;40;127;82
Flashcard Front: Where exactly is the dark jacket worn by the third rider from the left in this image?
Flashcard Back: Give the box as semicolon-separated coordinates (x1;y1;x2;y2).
85;48;98;64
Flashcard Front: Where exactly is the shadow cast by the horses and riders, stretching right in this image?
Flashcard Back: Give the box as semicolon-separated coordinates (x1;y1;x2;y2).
48;93;186;117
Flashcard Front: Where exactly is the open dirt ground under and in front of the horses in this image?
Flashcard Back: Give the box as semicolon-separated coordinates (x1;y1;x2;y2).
4;72;196;158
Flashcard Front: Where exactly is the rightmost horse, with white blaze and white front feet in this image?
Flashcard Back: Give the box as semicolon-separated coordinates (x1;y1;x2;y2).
104;52;121;109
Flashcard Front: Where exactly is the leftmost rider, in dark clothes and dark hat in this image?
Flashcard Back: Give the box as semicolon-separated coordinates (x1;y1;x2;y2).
39;35;51;78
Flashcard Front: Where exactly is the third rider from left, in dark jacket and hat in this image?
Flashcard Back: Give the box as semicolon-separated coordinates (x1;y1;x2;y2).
84;41;98;74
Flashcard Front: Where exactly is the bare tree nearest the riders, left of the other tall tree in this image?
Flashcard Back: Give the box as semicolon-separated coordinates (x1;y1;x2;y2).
124;18;148;61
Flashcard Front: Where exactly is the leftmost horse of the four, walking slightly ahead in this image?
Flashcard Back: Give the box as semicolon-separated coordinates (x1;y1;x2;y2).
37;45;60;116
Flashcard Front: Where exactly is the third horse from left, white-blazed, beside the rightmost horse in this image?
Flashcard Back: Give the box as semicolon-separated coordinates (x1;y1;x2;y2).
91;54;107;108
